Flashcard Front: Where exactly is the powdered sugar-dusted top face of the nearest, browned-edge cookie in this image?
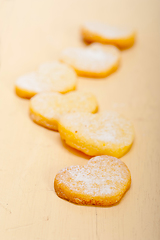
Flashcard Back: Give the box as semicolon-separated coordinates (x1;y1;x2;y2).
56;156;130;197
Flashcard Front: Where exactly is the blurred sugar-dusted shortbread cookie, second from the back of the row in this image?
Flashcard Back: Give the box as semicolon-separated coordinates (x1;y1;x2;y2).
60;43;120;77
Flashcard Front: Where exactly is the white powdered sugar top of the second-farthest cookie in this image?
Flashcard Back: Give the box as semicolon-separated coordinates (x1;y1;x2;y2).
61;44;119;72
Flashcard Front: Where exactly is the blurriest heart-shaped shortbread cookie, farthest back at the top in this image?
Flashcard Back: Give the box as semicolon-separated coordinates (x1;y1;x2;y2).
81;22;135;48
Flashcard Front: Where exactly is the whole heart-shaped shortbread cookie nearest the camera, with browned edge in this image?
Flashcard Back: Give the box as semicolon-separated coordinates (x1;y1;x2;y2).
54;155;131;206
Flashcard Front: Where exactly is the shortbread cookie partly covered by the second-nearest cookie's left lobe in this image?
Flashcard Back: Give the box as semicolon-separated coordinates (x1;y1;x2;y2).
30;91;98;130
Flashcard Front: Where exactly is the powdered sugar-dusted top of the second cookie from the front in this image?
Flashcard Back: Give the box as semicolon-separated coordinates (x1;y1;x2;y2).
61;111;133;144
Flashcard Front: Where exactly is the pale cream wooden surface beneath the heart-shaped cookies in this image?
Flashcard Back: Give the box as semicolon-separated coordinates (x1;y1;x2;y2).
0;0;160;240
